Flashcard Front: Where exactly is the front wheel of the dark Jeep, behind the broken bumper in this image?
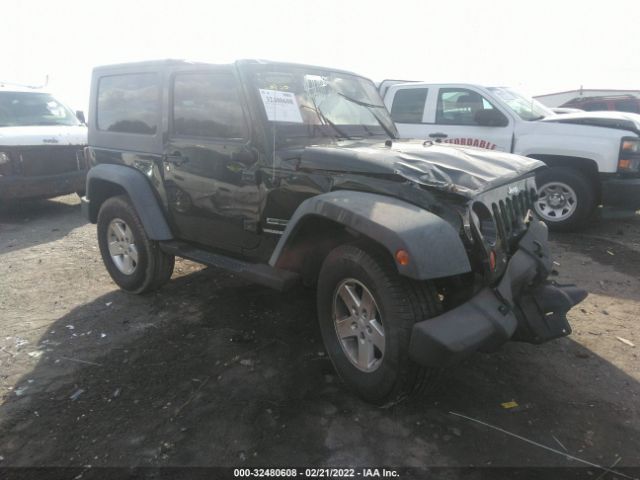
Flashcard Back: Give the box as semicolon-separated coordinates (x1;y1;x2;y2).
317;245;440;405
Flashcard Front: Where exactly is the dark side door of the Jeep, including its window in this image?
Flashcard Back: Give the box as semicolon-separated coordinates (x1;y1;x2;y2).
163;68;260;252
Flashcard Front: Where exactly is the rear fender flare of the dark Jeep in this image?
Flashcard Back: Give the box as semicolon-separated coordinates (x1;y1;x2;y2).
87;164;173;240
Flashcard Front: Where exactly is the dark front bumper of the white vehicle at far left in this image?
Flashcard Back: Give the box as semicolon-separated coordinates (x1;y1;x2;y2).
0;170;87;200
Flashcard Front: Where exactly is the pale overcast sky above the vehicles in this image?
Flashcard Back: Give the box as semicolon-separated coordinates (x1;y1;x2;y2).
0;0;640;111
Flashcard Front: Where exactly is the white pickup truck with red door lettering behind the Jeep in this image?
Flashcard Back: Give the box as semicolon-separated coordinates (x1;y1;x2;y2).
380;81;640;230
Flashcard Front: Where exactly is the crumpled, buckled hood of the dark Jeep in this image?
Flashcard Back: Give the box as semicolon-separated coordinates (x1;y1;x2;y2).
299;140;544;198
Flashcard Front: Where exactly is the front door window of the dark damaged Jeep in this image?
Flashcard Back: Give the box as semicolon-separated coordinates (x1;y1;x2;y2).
173;73;247;139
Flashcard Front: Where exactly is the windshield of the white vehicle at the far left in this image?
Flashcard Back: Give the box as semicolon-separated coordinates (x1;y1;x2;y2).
0;92;80;127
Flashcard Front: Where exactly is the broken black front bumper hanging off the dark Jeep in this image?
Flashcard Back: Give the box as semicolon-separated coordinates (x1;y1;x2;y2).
409;221;587;367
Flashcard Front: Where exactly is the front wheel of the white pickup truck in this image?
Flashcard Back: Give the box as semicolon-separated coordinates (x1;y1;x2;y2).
535;167;596;231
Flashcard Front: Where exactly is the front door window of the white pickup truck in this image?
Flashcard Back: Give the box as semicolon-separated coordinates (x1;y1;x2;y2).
436;88;506;126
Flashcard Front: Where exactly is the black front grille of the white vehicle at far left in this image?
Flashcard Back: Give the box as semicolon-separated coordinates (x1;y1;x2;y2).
14;145;84;177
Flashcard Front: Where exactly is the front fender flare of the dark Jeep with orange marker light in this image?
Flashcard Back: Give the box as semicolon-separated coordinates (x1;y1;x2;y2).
269;190;471;280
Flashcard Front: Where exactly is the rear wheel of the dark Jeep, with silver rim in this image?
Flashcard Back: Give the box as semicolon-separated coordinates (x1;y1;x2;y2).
98;195;175;293
